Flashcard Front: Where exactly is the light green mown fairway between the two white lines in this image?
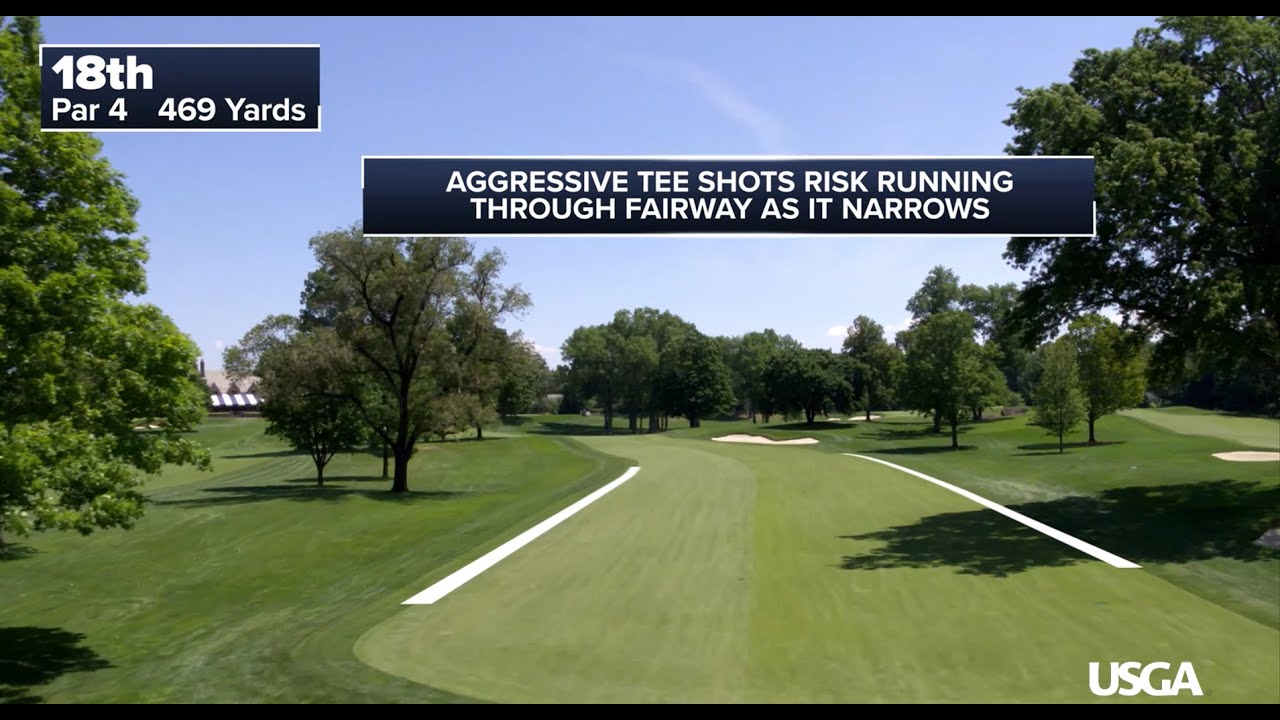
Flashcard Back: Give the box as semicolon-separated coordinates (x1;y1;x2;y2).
356;427;1280;702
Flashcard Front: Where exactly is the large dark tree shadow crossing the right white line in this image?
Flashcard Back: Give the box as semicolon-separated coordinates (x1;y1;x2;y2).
841;480;1280;578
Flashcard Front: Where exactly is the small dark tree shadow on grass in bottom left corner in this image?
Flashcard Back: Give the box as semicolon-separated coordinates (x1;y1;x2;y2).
0;626;111;705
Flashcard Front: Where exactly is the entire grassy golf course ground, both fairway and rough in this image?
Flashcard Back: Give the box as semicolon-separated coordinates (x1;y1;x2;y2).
0;409;1280;702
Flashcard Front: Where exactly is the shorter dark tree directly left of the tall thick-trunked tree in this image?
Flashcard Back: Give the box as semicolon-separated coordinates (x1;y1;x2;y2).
255;331;367;486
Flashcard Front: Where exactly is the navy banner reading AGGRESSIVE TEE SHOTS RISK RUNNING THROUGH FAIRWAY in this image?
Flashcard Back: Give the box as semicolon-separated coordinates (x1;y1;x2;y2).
362;156;1093;237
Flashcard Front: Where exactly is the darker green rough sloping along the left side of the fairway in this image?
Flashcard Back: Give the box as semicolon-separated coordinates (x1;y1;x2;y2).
0;420;626;702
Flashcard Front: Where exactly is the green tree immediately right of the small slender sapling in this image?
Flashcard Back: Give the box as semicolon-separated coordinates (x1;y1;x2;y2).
1066;314;1147;445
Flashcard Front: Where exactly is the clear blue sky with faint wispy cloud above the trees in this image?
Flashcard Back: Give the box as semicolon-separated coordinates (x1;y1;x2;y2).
44;17;1151;368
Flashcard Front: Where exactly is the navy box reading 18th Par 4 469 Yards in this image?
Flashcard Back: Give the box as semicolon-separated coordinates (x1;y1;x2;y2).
40;45;320;132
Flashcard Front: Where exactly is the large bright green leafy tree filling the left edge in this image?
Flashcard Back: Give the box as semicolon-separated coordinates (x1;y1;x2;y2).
0;17;209;550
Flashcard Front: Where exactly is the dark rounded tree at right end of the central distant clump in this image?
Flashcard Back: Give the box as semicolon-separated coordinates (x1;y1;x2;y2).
662;328;733;428
